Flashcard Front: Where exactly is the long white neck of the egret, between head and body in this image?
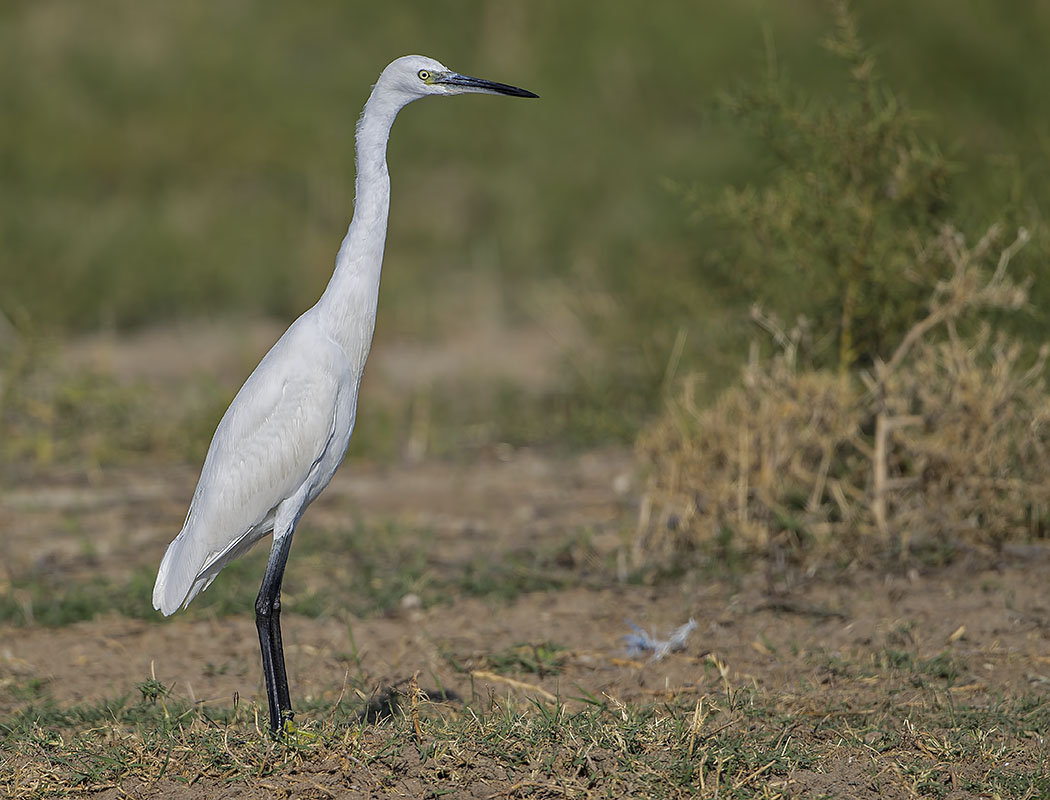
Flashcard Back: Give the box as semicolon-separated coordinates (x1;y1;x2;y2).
314;83;404;365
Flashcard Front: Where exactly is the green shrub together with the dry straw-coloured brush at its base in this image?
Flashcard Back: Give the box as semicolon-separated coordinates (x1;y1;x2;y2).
635;4;1050;562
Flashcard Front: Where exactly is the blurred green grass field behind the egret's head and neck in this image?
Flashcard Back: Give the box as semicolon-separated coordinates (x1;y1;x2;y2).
0;0;1050;333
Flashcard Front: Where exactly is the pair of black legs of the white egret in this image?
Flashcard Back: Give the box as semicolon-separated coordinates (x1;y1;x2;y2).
255;531;292;736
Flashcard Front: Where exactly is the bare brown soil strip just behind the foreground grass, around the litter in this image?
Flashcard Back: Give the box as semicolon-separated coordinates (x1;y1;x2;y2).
8;550;1050;710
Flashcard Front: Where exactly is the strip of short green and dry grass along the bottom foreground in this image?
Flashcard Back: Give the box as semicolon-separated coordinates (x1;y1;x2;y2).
0;667;1050;799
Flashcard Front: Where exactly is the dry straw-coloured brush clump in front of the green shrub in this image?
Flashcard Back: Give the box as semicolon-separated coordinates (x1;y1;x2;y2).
635;228;1050;561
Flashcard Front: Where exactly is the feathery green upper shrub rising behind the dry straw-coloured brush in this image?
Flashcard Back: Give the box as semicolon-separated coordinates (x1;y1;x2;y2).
707;4;952;369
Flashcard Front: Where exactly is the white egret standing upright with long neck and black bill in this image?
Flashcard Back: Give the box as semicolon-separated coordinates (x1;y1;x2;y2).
153;56;538;734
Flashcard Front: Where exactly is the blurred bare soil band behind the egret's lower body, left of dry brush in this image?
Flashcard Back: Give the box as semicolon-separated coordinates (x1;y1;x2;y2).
0;449;635;580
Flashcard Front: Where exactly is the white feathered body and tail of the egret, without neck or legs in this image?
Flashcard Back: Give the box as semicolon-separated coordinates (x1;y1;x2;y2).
153;312;364;614
